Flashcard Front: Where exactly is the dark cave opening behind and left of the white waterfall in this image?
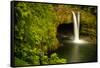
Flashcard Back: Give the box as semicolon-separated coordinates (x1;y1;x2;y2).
56;23;74;42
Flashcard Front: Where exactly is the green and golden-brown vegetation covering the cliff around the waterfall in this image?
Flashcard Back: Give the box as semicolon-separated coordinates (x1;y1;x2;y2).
14;2;96;66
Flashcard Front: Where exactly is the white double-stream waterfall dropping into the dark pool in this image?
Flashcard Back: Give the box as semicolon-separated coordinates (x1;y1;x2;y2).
72;11;80;41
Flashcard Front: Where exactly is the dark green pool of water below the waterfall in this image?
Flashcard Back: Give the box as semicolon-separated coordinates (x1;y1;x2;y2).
56;41;97;63
